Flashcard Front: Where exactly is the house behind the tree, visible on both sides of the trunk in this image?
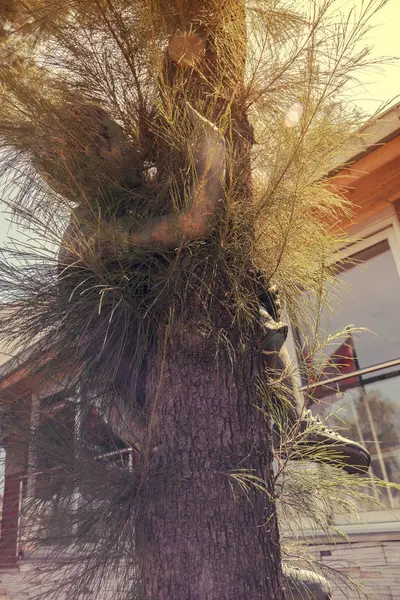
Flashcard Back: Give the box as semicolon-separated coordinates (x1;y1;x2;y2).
0;105;400;600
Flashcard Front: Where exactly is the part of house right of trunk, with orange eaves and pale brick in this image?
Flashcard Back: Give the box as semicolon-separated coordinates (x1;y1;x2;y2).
296;105;400;600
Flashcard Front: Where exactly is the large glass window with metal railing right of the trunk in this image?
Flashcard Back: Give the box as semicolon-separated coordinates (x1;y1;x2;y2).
304;228;400;509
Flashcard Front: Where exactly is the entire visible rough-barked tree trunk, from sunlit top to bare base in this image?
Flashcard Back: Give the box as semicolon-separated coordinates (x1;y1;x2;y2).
136;0;284;600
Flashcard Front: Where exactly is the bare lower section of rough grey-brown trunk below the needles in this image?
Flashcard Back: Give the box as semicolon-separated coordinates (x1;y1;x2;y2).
138;324;284;600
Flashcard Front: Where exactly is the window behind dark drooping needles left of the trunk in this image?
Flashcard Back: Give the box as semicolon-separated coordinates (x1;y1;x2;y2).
22;391;133;547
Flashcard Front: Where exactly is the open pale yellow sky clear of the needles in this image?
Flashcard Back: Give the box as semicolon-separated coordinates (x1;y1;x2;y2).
0;0;400;244
